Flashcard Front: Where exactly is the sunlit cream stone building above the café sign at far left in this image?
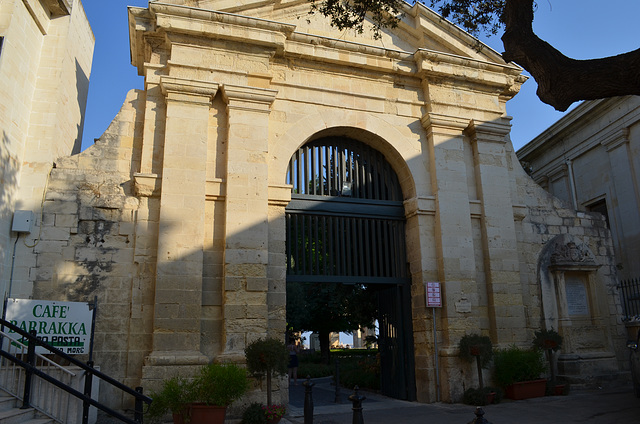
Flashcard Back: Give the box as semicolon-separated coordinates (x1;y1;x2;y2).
0;0;95;297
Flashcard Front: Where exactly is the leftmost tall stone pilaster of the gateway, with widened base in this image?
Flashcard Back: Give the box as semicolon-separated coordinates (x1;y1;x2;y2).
147;76;218;365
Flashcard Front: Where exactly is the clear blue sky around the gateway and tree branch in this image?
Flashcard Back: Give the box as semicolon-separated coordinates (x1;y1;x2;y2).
82;0;640;150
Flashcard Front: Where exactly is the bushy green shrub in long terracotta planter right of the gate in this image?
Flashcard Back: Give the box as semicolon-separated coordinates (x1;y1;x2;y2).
493;345;546;387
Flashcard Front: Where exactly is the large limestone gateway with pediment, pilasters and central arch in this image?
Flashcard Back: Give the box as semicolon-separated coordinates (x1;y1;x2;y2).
3;0;626;412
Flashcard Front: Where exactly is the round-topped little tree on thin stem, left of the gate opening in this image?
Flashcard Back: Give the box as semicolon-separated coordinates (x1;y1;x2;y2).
244;338;289;406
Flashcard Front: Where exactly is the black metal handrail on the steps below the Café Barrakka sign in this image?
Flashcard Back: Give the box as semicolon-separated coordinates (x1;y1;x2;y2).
0;319;152;424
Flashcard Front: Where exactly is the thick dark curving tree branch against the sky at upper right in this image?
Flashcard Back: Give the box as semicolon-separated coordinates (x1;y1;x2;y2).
502;0;640;111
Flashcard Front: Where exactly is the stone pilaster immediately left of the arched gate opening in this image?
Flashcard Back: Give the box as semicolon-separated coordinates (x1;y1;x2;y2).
222;85;277;359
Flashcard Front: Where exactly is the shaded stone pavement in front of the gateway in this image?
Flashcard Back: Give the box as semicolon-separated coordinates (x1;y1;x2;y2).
281;378;640;424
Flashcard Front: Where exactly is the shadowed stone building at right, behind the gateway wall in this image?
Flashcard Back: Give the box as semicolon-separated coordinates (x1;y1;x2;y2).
517;96;640;279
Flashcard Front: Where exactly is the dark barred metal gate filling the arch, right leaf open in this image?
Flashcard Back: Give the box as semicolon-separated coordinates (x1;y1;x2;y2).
286;137;416;400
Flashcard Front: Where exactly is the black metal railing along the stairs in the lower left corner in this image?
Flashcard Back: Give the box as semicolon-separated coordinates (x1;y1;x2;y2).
0;319;152;424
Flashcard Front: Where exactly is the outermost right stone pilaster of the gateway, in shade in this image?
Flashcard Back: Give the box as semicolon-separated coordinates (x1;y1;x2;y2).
467;120;527;343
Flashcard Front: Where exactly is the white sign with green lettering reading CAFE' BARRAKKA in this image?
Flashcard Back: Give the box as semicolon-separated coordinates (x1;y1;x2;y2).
7;299;93;355
